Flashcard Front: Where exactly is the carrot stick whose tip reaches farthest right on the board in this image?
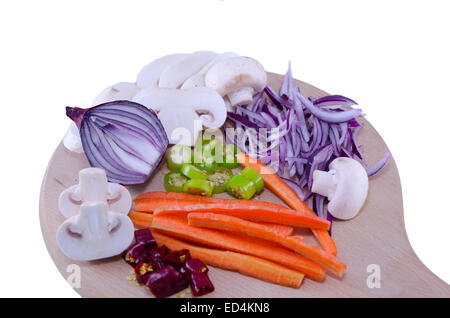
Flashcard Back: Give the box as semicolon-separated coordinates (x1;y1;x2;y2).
188;213;347;277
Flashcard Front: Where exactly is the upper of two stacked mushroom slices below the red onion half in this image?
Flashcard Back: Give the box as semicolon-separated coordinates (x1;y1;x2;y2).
58;168;132;218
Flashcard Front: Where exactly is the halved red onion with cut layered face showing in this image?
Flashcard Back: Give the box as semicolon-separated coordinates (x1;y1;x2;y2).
66;100;169;184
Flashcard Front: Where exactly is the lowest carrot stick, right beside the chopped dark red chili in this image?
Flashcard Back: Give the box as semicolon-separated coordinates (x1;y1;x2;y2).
153;231;305;288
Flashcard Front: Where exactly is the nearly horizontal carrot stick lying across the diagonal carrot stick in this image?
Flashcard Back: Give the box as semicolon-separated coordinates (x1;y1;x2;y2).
154;203;330;230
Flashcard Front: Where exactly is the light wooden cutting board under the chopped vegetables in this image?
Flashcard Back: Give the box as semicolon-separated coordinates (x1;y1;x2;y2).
39;73;450;298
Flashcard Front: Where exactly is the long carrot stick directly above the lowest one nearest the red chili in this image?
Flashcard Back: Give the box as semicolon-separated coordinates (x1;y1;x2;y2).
152;214;325;281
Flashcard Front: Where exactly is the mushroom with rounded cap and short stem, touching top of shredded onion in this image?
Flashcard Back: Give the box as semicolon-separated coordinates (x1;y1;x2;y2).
205;56;267;106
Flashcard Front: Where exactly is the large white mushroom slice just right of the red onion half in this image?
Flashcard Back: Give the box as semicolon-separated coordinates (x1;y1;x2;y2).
133;87;227;146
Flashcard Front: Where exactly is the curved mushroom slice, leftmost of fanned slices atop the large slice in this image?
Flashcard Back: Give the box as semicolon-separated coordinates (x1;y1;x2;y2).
136;53;188;88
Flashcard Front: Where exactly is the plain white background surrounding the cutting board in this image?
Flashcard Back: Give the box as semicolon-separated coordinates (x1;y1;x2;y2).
0;0;450;297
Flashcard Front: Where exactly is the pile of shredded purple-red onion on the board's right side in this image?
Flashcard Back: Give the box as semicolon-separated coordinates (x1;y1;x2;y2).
228;63;389;225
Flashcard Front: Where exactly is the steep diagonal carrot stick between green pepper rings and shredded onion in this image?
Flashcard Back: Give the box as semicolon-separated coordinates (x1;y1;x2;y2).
237;152;337;256
